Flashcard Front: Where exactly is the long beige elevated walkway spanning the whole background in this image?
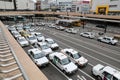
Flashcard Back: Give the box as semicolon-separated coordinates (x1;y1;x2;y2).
0;11;120;20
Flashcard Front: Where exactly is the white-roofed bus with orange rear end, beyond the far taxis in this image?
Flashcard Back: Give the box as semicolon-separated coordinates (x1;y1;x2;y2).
56;19;81;27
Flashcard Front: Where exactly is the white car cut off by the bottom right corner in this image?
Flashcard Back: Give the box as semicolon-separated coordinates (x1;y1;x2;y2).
91;64;120;80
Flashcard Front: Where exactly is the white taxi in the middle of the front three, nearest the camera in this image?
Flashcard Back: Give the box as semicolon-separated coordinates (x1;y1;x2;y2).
49;52;78;74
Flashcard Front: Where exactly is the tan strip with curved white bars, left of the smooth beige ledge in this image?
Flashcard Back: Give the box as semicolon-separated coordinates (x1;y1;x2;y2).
0;29;28;80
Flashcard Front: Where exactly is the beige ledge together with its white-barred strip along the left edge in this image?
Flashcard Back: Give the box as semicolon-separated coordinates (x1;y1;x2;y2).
0;22;48;80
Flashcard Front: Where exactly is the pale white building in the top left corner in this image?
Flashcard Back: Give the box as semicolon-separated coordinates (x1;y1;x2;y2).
0;0;35;10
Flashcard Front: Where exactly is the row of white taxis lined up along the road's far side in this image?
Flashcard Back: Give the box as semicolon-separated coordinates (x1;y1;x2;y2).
45;24;118;45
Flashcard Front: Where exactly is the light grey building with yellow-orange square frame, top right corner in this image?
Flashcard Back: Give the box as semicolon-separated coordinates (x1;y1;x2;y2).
91;0;120;15
